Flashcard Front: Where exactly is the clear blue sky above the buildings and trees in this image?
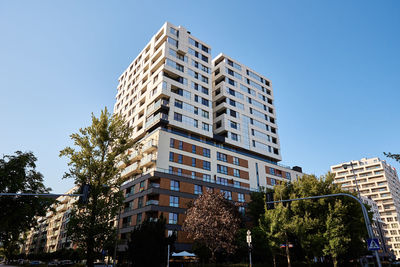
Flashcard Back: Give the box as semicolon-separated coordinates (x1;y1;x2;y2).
0;0;400;192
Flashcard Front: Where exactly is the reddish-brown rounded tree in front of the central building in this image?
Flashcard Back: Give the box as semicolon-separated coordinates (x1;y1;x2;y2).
183;190;240;262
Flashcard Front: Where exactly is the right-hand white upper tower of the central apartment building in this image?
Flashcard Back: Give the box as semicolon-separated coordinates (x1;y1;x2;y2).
213;54;282;161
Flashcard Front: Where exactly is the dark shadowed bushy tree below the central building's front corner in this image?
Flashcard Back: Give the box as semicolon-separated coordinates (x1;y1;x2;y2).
127;216;176;267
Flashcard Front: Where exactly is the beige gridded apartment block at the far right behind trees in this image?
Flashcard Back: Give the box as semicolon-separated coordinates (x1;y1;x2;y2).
331;158;400;258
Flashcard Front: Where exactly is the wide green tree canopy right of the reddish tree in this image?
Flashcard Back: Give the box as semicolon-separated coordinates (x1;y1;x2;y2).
260;173;367;265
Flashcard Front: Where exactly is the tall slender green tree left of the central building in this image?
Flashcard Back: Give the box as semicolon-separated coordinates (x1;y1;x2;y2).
60;108;133;267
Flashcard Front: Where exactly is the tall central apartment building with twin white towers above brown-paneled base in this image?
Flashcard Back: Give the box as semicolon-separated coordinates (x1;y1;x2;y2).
114;22;302;250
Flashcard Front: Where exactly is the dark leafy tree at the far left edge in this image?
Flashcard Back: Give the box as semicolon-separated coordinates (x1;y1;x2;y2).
0;151;53;259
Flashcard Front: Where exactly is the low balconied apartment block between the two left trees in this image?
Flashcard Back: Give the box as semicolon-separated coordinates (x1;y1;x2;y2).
21;188;77;254
